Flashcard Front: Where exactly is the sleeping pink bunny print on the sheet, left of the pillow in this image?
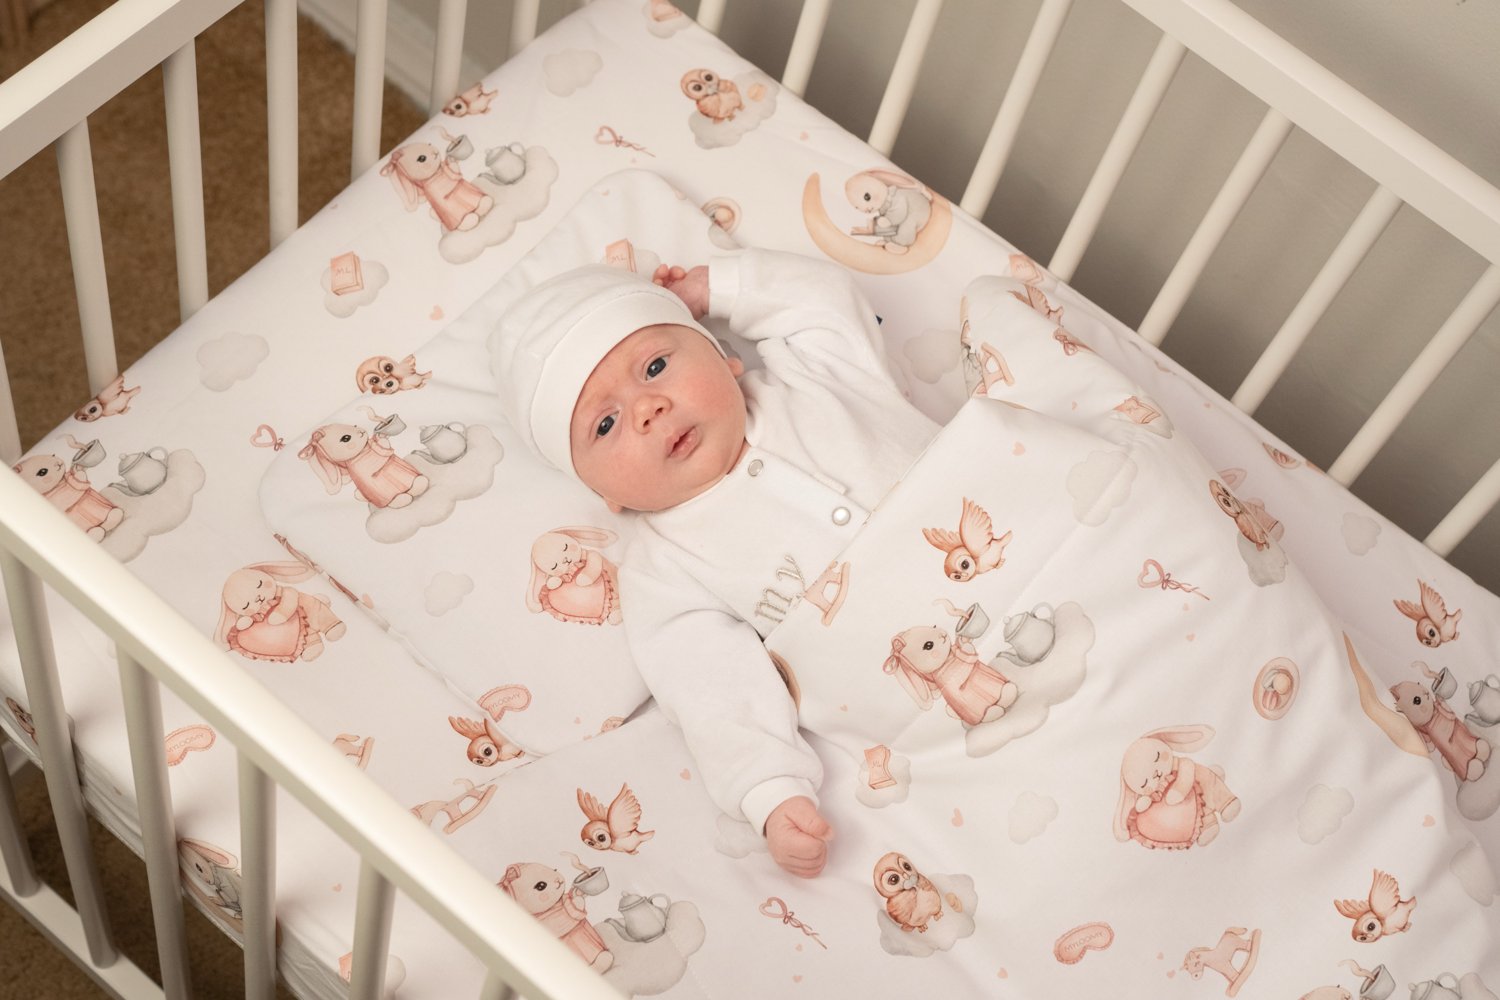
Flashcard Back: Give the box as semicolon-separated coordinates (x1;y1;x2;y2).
213;562;345;663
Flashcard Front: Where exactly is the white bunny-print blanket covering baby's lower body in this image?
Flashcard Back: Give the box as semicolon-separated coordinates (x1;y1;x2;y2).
435;277;1500;1000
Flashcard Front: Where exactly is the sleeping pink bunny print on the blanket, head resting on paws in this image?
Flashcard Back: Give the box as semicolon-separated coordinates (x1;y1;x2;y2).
1115;726;1241;850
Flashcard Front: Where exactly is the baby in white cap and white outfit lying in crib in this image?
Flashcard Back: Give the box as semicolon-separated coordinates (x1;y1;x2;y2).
492;250;938;877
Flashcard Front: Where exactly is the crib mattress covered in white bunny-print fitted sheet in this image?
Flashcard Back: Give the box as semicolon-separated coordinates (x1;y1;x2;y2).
0;0;1500;997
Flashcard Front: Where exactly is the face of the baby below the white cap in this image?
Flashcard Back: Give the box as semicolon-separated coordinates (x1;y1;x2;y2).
569;324;746;511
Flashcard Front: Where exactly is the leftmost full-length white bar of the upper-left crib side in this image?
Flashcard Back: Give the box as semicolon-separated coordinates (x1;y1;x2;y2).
57;118;120;393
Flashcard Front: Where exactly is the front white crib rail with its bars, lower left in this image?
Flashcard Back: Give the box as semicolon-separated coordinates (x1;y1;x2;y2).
0;469;617;1000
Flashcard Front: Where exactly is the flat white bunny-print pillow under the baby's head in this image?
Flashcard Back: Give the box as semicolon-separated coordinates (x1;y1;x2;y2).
265;171;744;763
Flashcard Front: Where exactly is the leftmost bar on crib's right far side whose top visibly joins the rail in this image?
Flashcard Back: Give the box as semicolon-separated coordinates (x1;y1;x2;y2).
1047;34;1188;282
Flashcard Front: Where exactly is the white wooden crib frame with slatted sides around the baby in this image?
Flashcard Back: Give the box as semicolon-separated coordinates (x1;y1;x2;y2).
0;0;1500;1000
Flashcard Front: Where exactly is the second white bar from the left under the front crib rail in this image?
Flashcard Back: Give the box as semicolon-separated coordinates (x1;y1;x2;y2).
116;651;192;1000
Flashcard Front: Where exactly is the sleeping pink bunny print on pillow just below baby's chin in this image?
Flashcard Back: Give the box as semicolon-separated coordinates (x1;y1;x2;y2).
527;528;623;625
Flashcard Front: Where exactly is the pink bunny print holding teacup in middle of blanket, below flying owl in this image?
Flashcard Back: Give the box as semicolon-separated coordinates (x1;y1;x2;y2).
882;625;1019;727
